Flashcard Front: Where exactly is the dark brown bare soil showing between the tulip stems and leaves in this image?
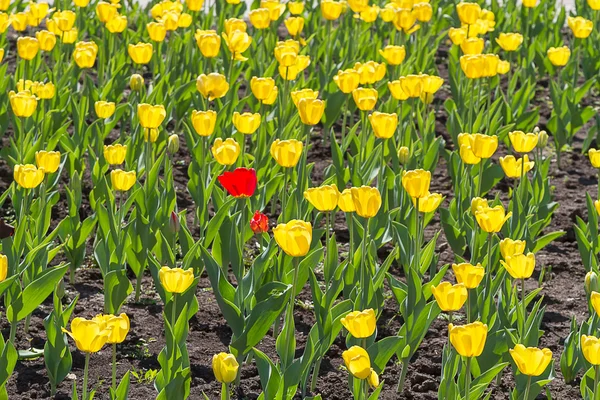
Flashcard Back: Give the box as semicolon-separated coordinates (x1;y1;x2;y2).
0;41;597;400
